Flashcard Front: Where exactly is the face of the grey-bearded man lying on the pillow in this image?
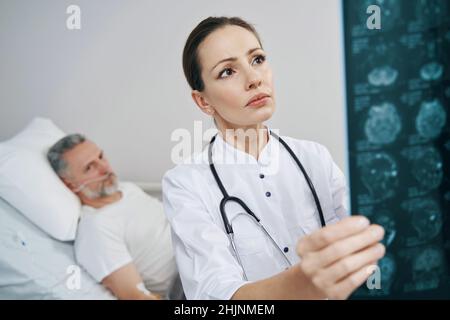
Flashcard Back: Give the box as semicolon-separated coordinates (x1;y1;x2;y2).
63;140;117;199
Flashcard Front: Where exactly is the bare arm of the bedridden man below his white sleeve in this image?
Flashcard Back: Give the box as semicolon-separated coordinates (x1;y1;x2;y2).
102;263;161;300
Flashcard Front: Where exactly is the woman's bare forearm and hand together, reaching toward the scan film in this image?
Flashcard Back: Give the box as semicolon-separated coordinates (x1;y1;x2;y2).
232;217;385;299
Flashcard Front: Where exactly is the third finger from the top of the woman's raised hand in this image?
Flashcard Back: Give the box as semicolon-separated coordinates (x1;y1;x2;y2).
311;243;386;288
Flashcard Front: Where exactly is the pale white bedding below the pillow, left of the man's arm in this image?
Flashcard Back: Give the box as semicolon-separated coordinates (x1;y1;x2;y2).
0;198;115;300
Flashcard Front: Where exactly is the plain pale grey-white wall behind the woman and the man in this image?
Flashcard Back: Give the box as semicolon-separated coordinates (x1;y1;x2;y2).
0;0;346;182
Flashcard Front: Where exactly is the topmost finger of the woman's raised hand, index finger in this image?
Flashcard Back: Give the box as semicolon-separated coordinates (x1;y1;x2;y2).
297;216;370;257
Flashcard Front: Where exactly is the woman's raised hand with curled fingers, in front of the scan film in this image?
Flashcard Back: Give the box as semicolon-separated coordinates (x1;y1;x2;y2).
296;216;385;299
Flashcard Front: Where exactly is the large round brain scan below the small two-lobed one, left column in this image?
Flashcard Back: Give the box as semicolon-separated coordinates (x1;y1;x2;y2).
364;102;402;144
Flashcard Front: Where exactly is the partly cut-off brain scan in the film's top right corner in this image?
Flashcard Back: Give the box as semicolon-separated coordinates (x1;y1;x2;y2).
415;0;448;28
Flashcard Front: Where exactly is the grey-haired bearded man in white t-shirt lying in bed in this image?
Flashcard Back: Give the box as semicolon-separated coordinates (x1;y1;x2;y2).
47;134;178;299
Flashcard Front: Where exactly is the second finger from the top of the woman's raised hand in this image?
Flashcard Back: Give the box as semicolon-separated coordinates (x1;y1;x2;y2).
300;225;384;275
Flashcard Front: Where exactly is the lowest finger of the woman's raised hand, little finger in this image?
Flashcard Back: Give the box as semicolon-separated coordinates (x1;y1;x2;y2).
325;261;376;300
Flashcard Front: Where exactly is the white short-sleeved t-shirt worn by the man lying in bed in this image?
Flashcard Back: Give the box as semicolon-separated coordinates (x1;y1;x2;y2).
75;183;177;295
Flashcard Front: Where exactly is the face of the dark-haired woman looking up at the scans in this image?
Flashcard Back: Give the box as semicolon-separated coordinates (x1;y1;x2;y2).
192;25;275;128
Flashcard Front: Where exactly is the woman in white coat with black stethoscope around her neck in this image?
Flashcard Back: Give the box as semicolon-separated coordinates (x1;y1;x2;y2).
163;17;385;299
